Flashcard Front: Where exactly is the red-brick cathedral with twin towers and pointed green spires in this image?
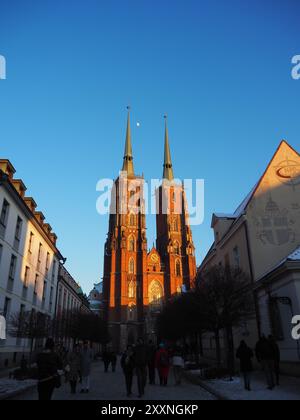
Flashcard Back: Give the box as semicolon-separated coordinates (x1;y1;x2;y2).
103;111;196;350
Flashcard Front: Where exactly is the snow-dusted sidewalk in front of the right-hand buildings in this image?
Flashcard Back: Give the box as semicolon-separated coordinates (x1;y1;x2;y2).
186;371;300;401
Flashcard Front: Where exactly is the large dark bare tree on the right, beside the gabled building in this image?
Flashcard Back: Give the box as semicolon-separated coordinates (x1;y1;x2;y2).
157;266;255;371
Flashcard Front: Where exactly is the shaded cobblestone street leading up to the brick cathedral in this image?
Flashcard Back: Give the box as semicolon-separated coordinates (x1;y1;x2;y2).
13;362;215;401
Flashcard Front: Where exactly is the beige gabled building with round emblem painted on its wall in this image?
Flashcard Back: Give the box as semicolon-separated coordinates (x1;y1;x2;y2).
201;141;300;373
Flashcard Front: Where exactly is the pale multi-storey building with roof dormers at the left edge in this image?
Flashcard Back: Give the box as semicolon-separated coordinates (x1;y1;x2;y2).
0;160;63;369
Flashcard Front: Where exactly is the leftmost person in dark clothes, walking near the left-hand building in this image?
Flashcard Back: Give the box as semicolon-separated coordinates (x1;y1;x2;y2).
37;338;62;401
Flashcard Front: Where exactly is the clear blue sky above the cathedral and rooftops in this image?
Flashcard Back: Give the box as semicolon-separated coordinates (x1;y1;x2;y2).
0;0;300;292
